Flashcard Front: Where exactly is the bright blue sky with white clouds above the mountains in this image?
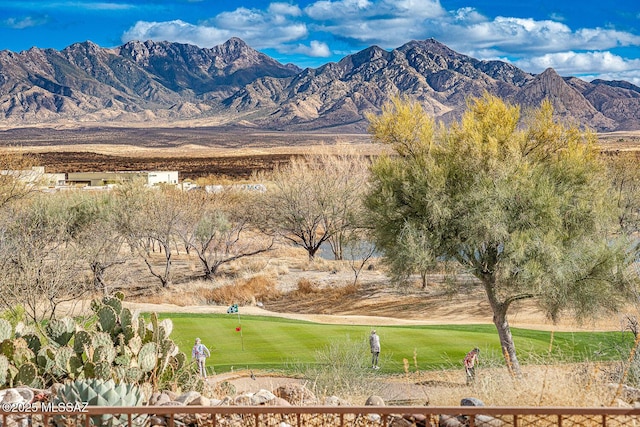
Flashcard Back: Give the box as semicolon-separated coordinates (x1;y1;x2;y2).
0;0;640;85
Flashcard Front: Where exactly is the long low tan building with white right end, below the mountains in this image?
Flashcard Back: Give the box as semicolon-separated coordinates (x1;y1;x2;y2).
67;171;178;187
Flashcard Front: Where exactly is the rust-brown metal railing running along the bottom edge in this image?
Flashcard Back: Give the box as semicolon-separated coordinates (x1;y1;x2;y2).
0;406;640;427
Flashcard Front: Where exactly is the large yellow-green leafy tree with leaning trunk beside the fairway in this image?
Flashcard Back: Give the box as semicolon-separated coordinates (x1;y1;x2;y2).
366;94;629;374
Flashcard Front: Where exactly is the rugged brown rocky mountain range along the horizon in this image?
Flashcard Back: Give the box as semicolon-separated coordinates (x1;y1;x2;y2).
0;38;640;133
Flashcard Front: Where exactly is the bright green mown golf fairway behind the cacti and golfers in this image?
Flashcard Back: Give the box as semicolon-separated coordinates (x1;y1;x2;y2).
159;313;633;373
